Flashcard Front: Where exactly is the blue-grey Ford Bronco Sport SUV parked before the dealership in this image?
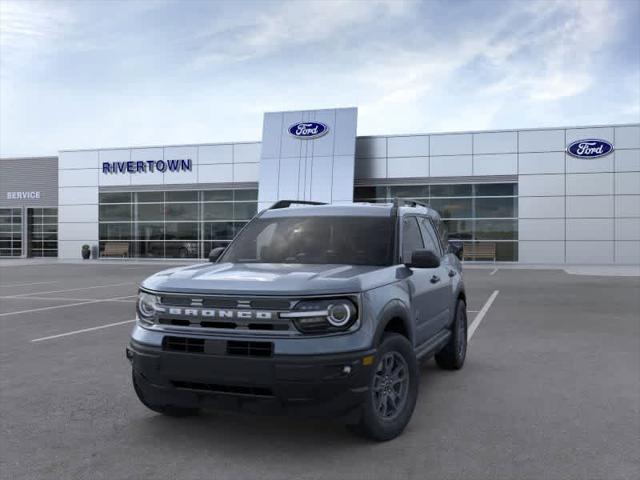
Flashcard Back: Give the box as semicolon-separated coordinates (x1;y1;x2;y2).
127;200;467;441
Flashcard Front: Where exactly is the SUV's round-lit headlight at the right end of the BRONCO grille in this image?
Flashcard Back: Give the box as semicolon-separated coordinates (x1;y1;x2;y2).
280;298;358;333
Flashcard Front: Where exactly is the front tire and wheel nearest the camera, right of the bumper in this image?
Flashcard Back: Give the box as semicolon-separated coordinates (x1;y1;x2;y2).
349;333;419;442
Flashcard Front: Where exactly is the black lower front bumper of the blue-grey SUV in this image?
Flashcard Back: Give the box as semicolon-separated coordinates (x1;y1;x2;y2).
127;340;375;420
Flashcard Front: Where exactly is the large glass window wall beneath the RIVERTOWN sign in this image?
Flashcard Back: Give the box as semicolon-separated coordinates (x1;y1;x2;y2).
99;189;258;258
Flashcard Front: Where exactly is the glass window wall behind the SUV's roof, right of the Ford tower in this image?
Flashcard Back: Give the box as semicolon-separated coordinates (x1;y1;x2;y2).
354;182;518;261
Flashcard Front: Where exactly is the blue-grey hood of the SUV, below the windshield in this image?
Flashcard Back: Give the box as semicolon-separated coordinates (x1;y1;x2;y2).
141;263;397;295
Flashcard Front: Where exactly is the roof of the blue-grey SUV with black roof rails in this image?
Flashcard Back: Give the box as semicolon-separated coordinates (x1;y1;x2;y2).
261;203;440;219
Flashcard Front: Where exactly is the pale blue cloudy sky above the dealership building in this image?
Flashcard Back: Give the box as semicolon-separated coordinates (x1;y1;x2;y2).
0;0;640;157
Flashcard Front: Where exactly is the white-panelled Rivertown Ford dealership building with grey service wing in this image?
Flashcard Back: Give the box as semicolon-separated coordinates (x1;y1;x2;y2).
0;108;640;264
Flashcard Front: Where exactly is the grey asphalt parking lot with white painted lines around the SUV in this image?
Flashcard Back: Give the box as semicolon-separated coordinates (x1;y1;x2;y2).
0;261;640;479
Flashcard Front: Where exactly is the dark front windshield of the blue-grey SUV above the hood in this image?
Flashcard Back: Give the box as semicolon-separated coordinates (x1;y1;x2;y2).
220;216;393;266
